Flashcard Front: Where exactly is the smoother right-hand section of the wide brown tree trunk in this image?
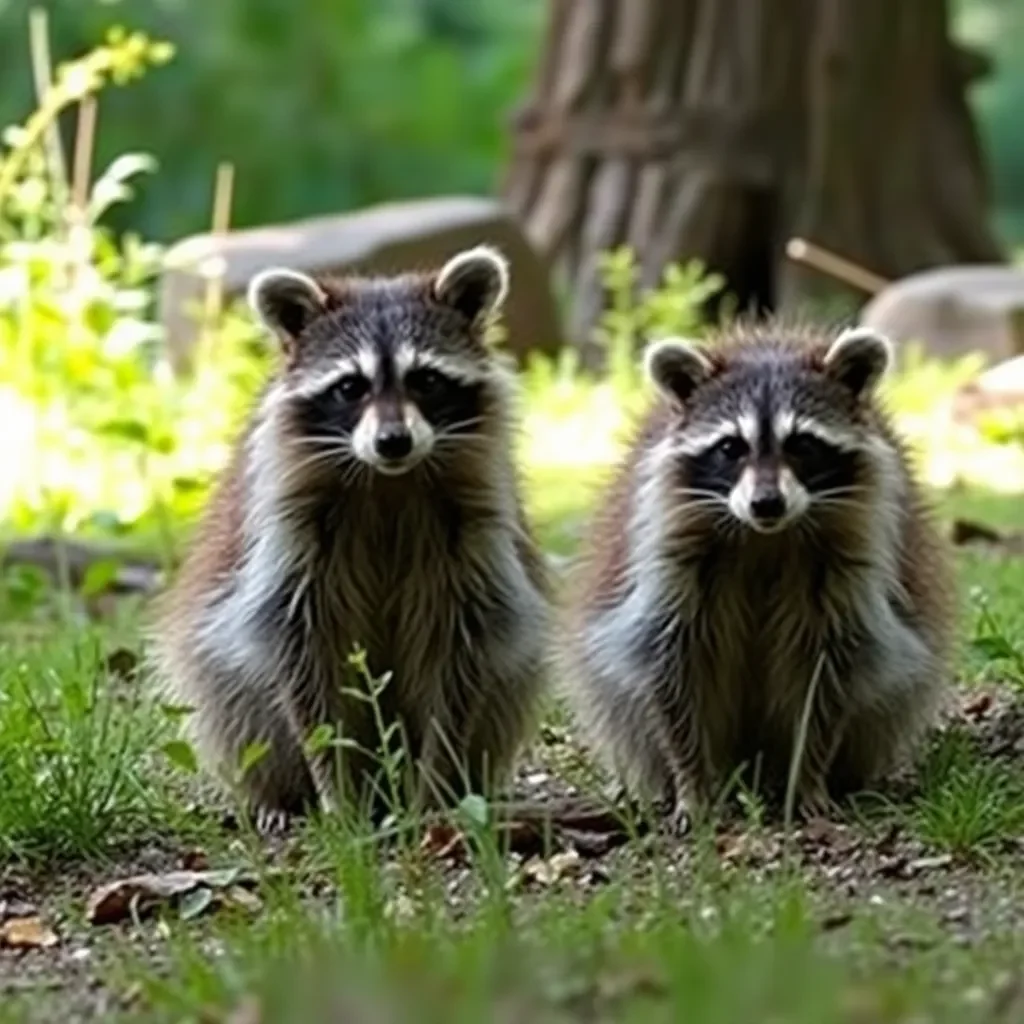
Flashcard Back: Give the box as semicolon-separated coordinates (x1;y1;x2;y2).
780;0;1001;306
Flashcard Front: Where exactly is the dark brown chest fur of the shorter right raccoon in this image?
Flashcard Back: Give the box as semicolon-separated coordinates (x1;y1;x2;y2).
663;539;886;776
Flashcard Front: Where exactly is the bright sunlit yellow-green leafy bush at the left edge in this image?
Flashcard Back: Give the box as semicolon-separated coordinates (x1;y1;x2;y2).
0;32;266;557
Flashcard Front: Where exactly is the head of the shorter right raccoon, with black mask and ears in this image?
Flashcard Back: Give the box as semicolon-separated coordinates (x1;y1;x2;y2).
645;329;892;534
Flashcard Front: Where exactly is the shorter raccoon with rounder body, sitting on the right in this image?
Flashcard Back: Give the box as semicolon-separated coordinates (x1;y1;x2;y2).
560;321;955;831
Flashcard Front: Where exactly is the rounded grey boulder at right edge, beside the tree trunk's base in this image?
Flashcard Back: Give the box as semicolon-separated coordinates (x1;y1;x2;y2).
860;264;1024;360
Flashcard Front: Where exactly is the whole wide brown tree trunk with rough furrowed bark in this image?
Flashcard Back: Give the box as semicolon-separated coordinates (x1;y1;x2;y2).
504;0;1000;361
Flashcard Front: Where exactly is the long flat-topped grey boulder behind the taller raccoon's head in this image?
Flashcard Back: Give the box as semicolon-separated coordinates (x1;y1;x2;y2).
160;197;563;369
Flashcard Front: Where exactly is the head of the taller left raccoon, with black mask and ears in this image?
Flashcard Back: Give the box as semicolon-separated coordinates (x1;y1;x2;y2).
249;246;508;476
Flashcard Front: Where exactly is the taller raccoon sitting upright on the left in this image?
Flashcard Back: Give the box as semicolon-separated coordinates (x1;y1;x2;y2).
153;246;551;828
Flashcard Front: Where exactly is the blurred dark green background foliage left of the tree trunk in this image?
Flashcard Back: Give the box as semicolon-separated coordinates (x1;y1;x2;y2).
0;0;545;240
